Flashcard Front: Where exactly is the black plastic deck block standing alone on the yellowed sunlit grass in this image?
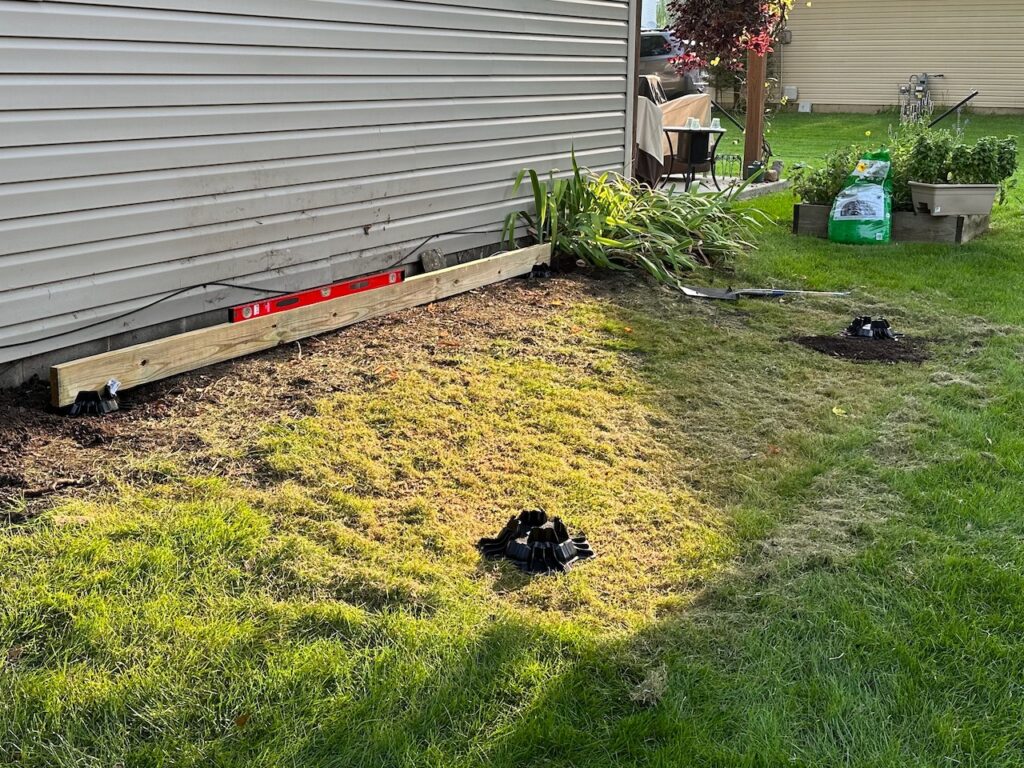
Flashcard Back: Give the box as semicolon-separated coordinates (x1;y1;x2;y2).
477;509;594;573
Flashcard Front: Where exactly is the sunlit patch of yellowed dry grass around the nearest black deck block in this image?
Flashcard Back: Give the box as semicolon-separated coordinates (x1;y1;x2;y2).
245;325;735;627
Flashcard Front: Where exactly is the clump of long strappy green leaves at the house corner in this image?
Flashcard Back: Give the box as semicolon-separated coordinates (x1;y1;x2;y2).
505;157;764;287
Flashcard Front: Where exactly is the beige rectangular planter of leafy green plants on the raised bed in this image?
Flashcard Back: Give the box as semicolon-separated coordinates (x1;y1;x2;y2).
906;131;1017;216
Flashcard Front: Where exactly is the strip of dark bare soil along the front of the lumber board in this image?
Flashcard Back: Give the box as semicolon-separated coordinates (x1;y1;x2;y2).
0;275;589;520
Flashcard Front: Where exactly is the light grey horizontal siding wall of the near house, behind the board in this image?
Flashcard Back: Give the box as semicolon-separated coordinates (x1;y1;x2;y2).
0;0;635;384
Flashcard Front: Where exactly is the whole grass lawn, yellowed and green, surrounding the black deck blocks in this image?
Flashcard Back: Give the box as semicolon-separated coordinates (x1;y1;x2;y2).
0;116;1024;768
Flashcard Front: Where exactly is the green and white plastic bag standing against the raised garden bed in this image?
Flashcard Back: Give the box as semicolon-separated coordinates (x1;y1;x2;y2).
828;150;893;245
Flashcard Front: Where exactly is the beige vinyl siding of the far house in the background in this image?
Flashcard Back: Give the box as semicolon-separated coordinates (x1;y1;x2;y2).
781;0;1024;111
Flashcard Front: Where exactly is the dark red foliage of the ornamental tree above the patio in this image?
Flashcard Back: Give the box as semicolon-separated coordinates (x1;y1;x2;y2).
669;0;793;69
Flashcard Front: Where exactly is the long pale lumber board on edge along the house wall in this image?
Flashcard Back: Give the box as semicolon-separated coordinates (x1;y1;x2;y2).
50;245;551;408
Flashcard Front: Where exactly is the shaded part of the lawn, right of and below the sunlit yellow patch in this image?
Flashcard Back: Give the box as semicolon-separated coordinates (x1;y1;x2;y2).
251;176;1024;768
